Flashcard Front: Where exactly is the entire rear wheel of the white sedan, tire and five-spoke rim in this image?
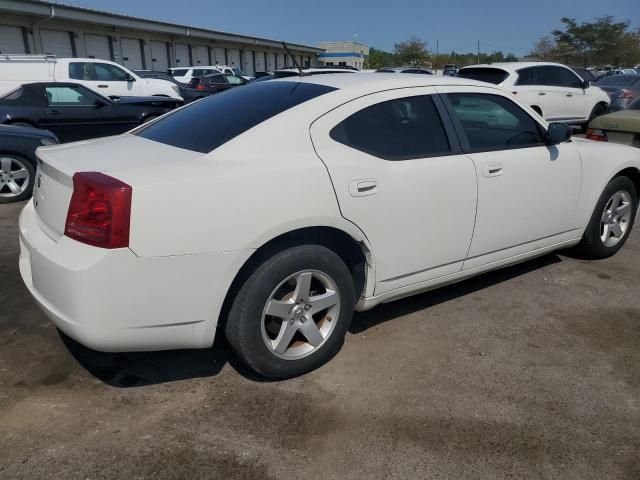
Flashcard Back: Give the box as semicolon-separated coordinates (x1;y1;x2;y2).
225;245;355;378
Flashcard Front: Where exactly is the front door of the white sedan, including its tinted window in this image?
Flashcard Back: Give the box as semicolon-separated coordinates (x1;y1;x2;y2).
437;87;581;269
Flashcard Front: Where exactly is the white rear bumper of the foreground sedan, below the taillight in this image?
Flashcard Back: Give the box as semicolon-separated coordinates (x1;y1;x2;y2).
19;202;252;352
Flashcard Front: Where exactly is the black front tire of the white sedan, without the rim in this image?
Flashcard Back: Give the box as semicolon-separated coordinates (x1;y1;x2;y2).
576;177;638;260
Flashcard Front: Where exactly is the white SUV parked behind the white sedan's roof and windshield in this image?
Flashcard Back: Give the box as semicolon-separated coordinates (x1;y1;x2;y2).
458;62;609;127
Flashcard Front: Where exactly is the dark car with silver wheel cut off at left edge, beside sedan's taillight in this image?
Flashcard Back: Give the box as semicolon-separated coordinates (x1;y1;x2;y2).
0;125;58;204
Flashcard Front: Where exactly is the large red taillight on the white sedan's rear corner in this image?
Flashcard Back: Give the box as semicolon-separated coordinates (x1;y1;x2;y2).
64;172;132;248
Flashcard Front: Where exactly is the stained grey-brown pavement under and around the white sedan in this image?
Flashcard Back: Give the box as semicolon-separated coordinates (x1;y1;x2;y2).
0;200;640;480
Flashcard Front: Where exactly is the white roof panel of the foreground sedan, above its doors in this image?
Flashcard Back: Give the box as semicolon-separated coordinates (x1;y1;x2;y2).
271;72;496;92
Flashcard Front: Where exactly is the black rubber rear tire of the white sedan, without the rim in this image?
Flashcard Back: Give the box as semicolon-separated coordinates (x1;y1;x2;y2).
225;245;355;379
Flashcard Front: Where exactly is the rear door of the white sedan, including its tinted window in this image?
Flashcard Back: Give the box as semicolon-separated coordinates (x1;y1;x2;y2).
311;87;477;294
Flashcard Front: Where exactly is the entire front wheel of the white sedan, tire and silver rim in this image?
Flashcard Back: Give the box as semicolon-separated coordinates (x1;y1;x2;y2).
577;177;638;259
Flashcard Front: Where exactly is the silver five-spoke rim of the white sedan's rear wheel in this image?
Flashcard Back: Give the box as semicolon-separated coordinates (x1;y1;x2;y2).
261;270;340;360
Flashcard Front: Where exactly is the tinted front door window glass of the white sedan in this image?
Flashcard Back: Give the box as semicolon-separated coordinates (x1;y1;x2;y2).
447;93;544;151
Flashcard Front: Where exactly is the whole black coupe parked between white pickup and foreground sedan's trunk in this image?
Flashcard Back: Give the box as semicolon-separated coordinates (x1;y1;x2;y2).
0;82;182;143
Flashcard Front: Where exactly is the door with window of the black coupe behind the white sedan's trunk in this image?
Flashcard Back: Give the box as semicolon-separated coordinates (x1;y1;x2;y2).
41;84;122;142
